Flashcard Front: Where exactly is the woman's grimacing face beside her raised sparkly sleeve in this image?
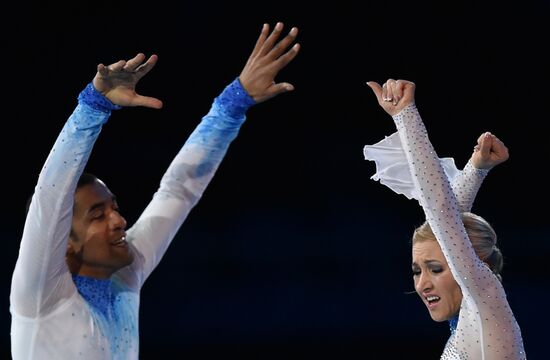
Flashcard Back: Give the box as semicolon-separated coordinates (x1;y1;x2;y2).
412;240;462;321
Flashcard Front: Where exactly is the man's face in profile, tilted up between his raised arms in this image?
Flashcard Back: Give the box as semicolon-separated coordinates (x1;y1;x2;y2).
67;180;134;278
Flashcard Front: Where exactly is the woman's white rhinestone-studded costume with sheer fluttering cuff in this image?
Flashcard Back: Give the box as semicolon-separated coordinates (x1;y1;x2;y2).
364;104;526;360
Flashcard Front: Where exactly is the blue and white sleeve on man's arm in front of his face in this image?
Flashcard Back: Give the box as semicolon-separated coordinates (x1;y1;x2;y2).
119;79;255;286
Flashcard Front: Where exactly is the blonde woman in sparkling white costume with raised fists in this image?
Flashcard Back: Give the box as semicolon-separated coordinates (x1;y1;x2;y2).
364;79;525;360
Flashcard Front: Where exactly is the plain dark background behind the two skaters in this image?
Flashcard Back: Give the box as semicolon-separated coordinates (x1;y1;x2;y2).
0;0;550;359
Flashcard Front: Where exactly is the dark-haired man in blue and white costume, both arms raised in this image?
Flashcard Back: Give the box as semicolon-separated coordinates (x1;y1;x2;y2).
10;23;299;360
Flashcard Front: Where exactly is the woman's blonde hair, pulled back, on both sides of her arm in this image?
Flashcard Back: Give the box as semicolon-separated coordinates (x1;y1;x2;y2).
412;212;504;281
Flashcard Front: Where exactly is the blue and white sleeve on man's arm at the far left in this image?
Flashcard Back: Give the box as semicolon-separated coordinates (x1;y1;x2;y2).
10;83;117;318
